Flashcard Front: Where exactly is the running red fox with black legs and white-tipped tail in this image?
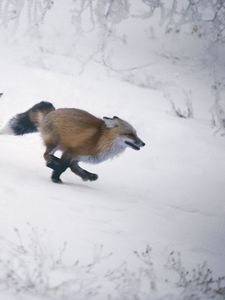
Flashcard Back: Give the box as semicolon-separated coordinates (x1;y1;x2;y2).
0;101;145;183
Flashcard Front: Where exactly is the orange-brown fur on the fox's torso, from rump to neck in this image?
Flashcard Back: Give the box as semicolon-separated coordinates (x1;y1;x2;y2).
40;109;119;157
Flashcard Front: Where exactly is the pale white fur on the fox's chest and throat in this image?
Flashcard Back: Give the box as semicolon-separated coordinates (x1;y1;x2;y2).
77;138;126;164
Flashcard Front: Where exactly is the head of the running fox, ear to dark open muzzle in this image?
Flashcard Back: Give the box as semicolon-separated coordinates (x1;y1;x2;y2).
103;116;145;150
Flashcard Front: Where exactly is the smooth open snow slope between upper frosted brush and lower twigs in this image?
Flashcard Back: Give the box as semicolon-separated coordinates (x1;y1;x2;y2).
0;36;225;300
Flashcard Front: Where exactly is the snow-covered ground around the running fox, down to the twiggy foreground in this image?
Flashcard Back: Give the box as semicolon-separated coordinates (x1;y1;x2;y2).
0;3;225;300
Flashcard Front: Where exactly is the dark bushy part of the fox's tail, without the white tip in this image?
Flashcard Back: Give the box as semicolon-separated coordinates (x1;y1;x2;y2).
9;101;55;135
